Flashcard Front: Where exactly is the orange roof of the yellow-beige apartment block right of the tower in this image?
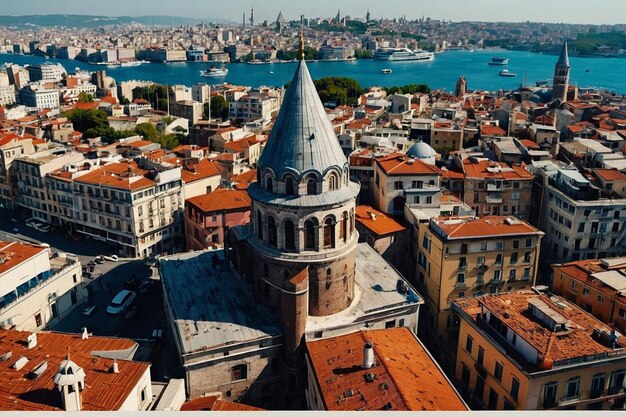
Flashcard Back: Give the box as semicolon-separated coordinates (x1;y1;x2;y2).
431;216;543;240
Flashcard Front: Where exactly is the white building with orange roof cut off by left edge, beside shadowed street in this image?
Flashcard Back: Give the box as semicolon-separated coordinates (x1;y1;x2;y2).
0;242;86;331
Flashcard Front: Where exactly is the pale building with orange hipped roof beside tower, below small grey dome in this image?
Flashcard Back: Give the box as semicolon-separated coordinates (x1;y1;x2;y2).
372;152;441;216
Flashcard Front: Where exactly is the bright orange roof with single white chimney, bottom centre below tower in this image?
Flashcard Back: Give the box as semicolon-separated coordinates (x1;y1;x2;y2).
307;327;468;411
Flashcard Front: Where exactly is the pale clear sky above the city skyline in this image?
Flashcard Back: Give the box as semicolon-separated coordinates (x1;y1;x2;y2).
0;0;626;24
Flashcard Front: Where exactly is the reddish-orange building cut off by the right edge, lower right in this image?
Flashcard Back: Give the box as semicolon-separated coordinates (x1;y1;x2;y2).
552;258;626;334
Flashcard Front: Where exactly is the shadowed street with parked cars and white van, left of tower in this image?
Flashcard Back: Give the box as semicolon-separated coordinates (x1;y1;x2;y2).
0;210;179;380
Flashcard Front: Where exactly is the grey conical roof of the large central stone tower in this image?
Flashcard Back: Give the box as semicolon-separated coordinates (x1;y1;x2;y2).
258;59;348;177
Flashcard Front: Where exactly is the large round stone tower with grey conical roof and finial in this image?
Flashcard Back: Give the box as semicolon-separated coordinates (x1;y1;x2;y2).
248;29;360;400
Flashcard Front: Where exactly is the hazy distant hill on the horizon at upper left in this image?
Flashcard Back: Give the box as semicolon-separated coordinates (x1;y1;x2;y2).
0;14;227;28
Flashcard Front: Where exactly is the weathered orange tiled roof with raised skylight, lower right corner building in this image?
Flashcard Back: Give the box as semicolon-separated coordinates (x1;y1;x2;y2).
453;291;626;371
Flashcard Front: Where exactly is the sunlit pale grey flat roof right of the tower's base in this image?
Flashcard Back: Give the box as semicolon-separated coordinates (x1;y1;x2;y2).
305;243;423;333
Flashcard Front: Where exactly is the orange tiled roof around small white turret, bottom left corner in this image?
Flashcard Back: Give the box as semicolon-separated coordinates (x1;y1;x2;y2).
0;329;150;411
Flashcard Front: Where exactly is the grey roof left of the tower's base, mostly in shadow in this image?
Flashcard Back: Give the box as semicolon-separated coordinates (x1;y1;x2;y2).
159;250;281;354
